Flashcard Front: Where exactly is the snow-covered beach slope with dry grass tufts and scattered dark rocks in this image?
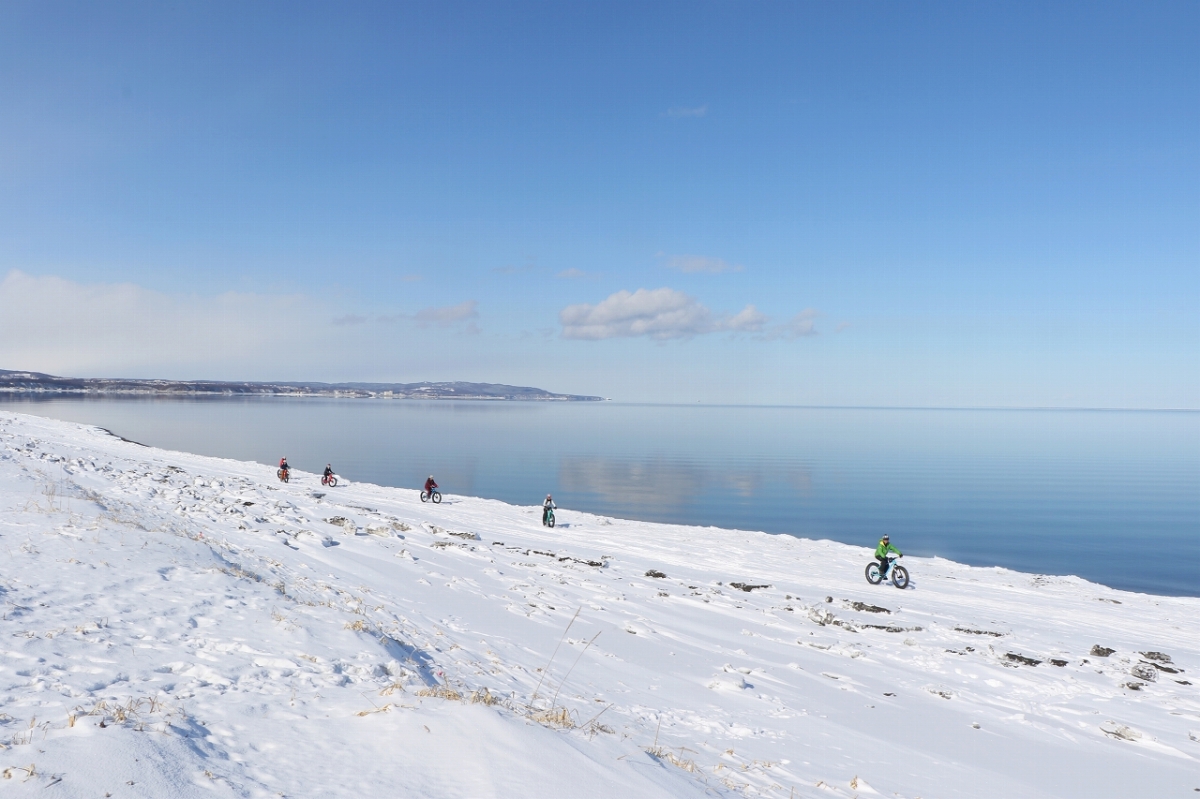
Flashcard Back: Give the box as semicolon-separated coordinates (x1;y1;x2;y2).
0;413;1200;799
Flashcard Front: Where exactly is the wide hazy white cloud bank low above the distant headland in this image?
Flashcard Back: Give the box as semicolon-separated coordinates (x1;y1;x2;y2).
0;270;492;380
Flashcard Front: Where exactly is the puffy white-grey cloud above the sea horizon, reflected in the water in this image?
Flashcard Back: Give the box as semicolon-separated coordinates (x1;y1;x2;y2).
558;288;767;341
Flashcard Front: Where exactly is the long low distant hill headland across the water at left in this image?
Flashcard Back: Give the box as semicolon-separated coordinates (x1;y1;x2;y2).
0;370;604;402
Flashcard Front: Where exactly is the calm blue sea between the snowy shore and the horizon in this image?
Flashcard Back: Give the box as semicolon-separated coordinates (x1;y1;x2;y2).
0;397;1200;595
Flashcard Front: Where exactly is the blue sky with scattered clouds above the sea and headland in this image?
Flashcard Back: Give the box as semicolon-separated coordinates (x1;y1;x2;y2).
0;2;1200;408
